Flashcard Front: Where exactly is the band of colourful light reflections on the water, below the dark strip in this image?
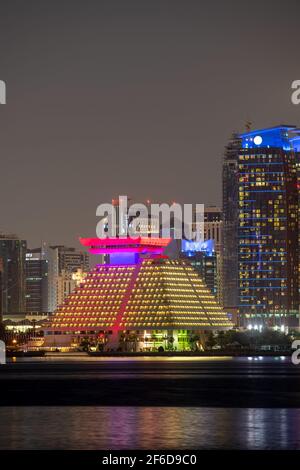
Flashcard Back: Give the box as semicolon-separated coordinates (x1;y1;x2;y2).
0;406;300;449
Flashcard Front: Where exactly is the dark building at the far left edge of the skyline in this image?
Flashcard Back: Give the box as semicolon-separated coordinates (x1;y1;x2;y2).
0;234;27;314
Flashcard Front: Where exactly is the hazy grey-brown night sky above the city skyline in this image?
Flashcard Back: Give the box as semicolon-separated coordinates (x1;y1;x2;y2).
0;0;300;246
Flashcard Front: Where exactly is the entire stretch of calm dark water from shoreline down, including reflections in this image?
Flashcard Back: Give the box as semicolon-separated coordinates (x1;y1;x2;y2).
0;355;300;450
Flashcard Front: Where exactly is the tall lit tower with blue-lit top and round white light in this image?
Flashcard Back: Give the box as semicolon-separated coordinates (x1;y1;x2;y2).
237;126;299;329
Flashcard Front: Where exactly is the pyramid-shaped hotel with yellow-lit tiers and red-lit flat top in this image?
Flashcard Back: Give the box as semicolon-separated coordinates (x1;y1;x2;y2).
45;237;232;350
